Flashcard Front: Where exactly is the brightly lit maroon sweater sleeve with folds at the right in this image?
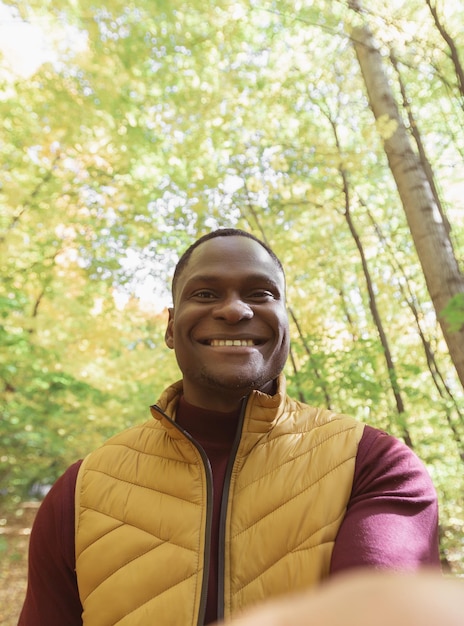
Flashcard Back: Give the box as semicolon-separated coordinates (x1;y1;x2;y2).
331;426;440;573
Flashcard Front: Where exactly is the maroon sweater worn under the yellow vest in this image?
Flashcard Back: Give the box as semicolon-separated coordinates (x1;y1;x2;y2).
18;400;439;626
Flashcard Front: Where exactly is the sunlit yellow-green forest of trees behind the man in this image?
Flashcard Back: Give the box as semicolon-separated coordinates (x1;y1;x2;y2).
0;0;464;575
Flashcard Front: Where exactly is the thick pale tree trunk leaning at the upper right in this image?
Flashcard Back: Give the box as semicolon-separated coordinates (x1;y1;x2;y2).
349;7;464;387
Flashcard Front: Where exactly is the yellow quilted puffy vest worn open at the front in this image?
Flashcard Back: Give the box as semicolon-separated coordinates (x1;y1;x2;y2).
76;377;363;626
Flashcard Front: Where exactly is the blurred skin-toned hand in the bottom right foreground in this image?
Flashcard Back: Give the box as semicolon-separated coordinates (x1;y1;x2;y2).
218;570;464;626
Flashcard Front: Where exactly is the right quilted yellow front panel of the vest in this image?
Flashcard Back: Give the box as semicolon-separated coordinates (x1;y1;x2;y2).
224;390;364;617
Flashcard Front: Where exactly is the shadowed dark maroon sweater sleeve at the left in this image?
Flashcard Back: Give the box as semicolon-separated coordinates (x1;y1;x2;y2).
18;461;82;626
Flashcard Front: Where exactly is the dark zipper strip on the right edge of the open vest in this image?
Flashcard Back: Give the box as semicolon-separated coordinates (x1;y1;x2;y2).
217;397;248;621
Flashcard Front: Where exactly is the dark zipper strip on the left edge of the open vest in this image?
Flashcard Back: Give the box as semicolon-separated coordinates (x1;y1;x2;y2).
152;404;213;626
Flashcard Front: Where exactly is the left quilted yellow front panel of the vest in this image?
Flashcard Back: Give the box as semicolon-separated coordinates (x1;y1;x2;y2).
76;420;207;626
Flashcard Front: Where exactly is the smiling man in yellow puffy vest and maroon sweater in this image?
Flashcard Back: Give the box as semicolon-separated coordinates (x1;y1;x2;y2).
19;229;439;626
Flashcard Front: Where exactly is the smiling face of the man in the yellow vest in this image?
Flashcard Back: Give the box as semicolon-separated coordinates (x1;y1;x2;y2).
166;236;289;410
